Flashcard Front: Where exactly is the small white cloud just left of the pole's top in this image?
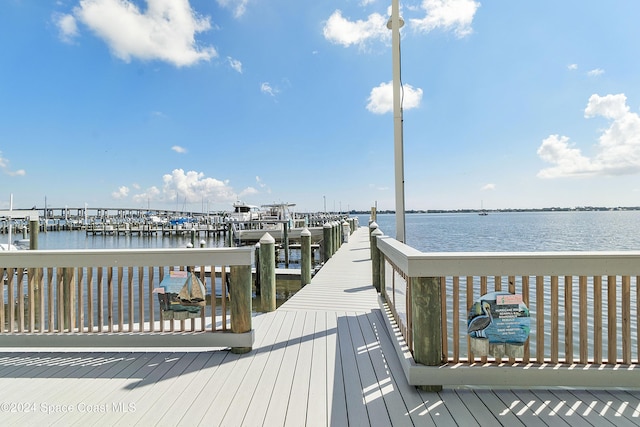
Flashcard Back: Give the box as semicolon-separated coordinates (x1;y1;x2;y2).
322;10;391;47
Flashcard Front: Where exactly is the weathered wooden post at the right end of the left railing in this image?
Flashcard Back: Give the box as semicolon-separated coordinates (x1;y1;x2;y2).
229;265;251;354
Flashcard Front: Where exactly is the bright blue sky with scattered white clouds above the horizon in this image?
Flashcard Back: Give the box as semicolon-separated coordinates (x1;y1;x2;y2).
0;0;640;211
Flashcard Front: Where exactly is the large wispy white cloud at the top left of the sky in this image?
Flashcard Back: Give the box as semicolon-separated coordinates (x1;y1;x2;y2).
73;0;217;67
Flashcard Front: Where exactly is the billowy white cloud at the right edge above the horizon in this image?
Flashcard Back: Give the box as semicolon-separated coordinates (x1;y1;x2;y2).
538;94;640;178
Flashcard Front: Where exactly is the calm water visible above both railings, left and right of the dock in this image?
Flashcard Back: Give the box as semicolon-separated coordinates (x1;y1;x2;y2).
6;211;640;252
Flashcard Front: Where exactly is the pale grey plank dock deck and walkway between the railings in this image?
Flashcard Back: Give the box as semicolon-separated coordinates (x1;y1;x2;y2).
0;228;640;427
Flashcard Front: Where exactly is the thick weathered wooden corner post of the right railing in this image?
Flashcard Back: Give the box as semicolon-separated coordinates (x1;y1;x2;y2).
408;277;442;391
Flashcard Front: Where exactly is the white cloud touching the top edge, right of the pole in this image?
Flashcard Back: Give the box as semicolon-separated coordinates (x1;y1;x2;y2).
409;0;480;38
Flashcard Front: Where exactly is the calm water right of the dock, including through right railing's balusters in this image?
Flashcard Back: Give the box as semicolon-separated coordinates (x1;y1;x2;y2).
360;211;640;358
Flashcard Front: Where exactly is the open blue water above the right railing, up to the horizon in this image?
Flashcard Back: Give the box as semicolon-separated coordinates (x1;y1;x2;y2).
359;211;640;252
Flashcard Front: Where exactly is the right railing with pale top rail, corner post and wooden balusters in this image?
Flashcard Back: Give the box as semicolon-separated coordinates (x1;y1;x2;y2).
374;232;640;386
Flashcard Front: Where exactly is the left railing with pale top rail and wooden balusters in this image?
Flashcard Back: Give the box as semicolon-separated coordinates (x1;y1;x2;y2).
0;247;254;352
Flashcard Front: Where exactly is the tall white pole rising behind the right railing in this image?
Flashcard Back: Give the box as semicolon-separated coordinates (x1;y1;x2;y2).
387;0;406;243
